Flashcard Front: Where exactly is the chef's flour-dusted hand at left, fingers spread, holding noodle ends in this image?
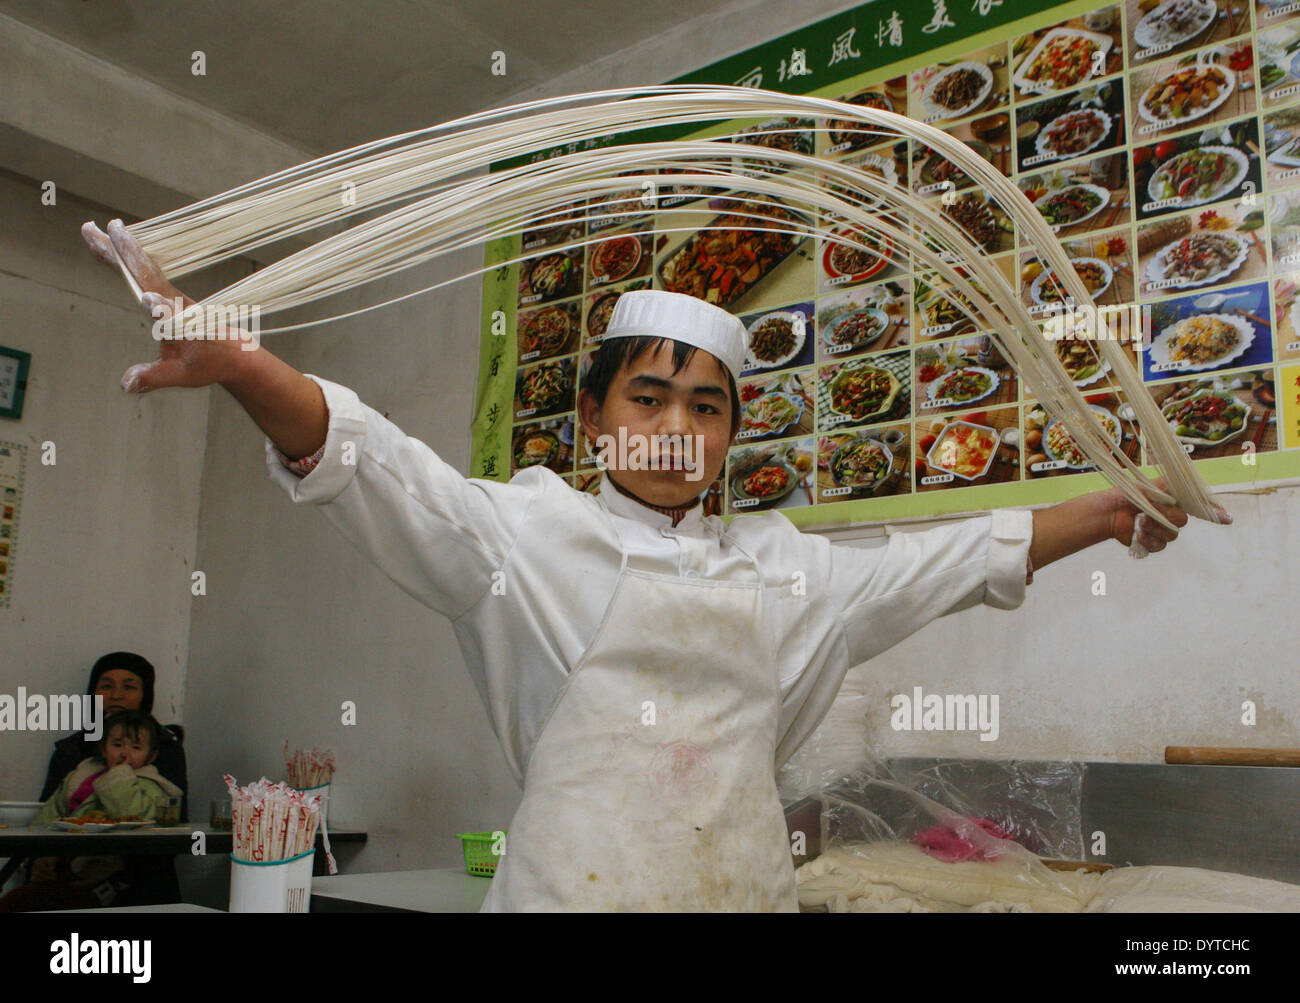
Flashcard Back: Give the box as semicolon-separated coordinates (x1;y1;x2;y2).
82;220;260;394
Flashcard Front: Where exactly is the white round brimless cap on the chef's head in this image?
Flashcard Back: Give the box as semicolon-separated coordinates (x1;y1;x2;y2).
603;290;749;379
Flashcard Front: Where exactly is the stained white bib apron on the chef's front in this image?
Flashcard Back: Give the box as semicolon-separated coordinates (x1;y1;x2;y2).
482;514;798;912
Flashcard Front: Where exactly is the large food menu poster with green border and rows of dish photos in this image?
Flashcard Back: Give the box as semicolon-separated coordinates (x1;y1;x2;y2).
472;0;1300;527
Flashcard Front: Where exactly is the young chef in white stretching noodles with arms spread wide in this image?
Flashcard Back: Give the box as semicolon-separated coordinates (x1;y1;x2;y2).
85;221;1216;911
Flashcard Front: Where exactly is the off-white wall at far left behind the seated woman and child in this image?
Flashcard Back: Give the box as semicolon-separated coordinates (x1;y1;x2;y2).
0;171;241;800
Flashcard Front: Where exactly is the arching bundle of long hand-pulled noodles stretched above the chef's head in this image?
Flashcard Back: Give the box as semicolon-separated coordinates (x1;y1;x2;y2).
96;84;1218;529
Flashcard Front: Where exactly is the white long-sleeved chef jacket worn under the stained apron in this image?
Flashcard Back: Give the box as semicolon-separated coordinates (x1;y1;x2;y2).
267;375;1032;785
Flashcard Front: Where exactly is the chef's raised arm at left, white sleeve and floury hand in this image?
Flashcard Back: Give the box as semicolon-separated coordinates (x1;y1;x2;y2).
82;220;527;618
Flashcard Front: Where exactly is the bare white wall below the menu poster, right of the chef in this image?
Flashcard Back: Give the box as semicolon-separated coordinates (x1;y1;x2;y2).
780;487;1300;789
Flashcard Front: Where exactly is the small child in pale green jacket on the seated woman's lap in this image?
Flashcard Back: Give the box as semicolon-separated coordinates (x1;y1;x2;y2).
35;711;181;825
